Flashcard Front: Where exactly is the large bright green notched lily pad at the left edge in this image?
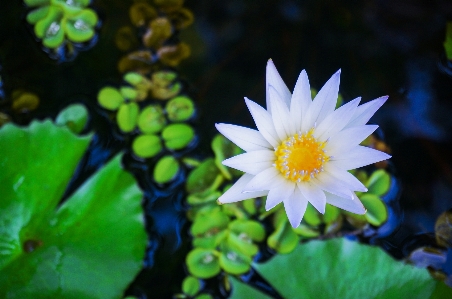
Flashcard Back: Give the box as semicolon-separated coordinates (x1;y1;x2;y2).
0;120;146;298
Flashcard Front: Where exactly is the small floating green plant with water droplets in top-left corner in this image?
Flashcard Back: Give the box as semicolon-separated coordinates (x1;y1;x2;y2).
24;0;99;59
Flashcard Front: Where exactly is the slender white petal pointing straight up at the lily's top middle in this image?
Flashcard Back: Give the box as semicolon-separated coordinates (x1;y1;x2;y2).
290;70;312;132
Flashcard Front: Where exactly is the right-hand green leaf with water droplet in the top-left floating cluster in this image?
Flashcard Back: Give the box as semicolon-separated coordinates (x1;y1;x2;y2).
62;9;98;43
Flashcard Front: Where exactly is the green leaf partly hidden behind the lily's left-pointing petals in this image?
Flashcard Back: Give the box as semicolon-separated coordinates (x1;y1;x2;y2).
211;134;243;180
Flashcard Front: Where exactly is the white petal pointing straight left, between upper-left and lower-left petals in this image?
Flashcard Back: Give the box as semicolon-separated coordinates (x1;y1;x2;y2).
223;150;275;175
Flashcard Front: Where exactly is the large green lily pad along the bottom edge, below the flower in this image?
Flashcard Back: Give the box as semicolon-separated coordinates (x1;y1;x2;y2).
230;239;452;299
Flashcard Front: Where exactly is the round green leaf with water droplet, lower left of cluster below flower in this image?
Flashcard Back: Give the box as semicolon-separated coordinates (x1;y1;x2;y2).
185;248;220;279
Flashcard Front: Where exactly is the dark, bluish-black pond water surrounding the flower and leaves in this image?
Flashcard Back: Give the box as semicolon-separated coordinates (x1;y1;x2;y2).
0;0;452;298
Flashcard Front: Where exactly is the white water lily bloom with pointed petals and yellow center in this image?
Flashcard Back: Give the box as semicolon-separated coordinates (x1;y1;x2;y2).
216;60;390;227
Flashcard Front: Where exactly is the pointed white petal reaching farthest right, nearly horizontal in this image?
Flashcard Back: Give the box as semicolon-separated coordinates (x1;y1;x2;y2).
328;145;391;170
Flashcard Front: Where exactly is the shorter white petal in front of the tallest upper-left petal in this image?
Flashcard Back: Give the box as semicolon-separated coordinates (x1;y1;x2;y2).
268;86;295;140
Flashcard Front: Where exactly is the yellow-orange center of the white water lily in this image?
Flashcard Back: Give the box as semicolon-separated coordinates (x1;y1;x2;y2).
274;129;329;183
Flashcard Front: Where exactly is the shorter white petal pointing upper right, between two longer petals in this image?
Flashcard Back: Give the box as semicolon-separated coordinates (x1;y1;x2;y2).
315;98;361;141
